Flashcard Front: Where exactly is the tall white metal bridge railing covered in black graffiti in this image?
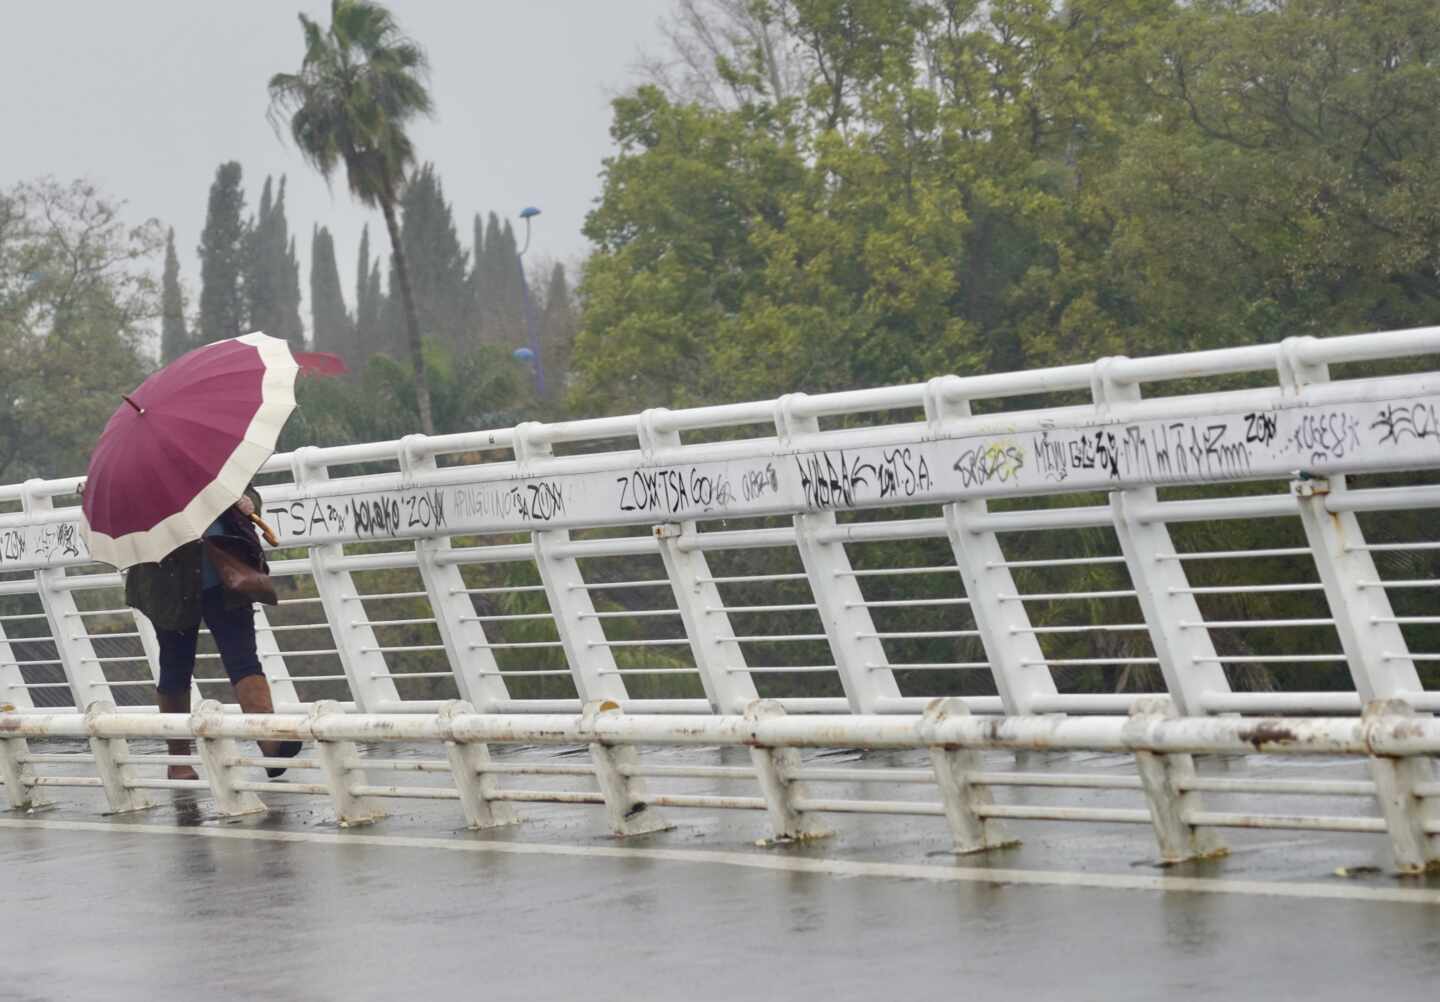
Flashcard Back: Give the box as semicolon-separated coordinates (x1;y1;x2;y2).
0;328;1440;716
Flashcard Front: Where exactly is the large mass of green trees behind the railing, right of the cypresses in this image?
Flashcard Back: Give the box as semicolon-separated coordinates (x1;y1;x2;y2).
569;0;1440;691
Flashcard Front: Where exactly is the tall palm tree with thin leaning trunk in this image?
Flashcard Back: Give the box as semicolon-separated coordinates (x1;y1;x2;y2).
269;0;435;435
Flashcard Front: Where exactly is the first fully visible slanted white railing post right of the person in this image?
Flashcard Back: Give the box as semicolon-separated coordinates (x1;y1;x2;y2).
292;446;400;713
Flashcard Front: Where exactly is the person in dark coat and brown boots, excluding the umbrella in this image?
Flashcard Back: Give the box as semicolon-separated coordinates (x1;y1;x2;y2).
125;485;301;779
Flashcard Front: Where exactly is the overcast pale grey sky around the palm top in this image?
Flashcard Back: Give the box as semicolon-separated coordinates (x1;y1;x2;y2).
0;0;670;313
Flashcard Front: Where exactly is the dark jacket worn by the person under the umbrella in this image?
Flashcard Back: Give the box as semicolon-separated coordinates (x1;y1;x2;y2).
125;485;269;631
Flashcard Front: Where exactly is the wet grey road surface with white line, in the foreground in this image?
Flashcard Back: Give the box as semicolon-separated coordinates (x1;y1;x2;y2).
0;743;1440;1001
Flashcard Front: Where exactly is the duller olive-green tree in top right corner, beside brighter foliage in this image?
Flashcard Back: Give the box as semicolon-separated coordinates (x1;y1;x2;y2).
1097;0;1440;344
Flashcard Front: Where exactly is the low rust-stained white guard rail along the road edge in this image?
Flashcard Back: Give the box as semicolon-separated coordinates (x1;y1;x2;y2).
0;697;1440;872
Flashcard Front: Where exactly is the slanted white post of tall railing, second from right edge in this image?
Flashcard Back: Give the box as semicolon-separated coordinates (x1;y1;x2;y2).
1092;357;1230;714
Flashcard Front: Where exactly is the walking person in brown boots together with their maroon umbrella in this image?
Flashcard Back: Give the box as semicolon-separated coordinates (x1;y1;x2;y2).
78;331;346;779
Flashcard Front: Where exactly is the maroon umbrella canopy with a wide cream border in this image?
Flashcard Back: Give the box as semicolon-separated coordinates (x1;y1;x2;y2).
82;331;301;567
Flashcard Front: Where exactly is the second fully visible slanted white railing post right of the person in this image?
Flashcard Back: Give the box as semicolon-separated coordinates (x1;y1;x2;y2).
400;435;510;713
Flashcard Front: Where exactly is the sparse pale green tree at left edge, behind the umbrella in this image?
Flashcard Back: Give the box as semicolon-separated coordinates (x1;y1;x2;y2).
0;180;166;482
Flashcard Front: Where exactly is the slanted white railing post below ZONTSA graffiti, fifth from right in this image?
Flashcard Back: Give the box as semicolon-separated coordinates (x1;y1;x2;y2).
639;407;759;713
